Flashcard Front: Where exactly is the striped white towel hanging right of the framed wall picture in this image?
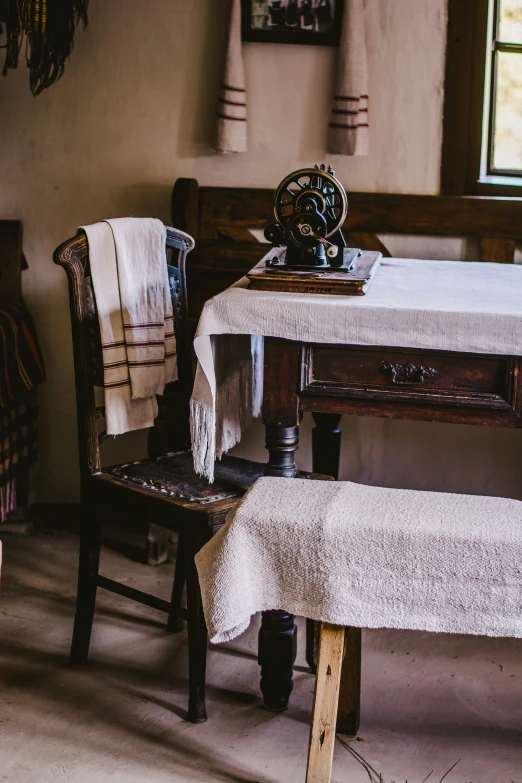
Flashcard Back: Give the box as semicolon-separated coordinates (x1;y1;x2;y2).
327;0;369;155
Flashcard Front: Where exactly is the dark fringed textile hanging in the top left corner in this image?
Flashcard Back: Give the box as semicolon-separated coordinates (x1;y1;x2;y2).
0;0;89;95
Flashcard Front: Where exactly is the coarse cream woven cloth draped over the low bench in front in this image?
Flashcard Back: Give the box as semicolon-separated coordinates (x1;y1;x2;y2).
196;477;522;642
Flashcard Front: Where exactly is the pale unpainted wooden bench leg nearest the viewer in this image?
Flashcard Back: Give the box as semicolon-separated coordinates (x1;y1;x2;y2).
306;623;345;783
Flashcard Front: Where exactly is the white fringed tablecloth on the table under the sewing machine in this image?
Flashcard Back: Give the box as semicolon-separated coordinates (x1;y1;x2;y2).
191;258;522;481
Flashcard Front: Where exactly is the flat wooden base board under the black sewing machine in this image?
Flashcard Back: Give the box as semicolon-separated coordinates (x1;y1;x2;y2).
247;247;382;296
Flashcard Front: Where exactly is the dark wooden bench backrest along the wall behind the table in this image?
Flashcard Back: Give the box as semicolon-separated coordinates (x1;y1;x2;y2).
172;179;522;332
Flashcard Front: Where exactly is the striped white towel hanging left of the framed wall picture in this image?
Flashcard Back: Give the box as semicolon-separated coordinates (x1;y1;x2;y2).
216;0;247;153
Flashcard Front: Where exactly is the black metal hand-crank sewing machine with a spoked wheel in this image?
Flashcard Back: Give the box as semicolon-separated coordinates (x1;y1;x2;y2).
265;163;361;271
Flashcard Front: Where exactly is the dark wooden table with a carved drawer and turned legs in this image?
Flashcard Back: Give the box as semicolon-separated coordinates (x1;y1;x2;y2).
259;338;522;735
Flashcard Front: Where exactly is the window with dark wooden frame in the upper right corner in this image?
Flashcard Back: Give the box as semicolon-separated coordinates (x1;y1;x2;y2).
441;0;522;197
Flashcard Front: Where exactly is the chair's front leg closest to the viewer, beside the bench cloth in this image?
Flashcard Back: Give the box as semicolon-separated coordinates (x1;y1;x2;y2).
184;540;208;723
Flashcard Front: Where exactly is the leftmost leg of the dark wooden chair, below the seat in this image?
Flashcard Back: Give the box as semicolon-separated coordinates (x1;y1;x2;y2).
70;511;101;664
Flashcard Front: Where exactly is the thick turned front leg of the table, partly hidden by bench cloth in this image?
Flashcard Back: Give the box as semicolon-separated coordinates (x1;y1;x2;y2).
258;338;300;711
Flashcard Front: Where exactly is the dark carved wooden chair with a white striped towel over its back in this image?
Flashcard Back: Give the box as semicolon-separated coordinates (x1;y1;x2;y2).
54;228;272;723
